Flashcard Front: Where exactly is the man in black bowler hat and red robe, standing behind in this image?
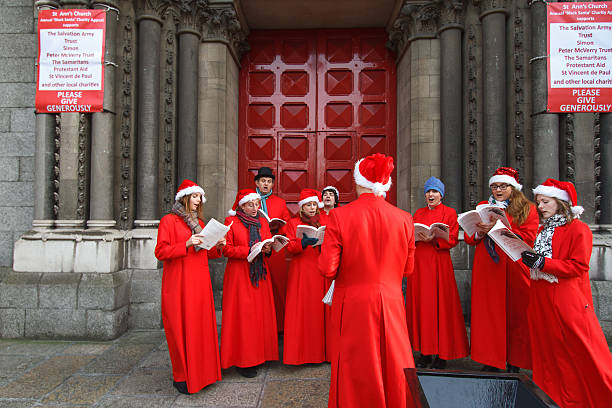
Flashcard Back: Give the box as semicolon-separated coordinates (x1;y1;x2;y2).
255;167;291;332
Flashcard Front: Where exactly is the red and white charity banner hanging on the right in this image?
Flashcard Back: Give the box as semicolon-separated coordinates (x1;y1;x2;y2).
546;1;612;113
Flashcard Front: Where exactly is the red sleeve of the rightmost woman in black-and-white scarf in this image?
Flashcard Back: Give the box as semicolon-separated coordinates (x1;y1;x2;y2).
542;221;593;278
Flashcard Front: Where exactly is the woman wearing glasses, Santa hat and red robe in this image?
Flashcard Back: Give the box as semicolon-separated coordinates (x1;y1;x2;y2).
464;167;538;372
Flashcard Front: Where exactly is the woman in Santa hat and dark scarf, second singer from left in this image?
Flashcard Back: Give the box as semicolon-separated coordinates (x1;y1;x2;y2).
221;189;278;378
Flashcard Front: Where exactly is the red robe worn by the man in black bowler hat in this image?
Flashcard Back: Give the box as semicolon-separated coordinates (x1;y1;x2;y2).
266;194;291;332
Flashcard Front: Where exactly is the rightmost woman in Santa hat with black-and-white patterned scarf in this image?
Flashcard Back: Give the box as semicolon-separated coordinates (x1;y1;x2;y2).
522;179;612;408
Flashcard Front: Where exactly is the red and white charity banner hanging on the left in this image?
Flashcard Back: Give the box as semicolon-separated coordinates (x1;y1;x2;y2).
36;9;106;113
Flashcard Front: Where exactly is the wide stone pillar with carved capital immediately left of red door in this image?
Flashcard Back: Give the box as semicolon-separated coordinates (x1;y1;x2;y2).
197;7;247;290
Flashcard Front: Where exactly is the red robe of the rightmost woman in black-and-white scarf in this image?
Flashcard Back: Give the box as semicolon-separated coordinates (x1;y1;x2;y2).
529;220;612;408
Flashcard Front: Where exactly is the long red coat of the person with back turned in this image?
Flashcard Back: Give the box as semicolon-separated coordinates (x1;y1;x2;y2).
319;193;414;408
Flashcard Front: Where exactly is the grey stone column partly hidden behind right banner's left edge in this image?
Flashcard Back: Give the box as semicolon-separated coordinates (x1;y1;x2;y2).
529;1;559;185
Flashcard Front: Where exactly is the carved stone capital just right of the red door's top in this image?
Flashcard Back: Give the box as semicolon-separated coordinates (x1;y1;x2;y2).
387;0;441;56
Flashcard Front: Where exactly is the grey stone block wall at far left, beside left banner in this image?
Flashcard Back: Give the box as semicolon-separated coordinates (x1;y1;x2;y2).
0;0;36;267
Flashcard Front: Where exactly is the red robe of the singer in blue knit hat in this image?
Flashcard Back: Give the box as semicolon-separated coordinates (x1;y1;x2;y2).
406;204;469;360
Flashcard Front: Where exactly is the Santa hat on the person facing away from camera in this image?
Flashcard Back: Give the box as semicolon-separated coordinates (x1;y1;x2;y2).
353;153;393;196
